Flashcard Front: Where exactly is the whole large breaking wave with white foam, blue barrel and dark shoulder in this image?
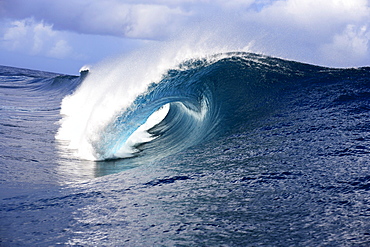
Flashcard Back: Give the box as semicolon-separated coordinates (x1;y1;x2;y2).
57;52;368;160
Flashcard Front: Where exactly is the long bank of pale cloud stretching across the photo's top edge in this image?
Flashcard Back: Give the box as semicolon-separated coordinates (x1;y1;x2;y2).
0;0;370;39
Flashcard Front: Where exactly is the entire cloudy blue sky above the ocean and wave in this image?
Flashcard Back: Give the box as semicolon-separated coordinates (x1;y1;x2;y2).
0;0;370;74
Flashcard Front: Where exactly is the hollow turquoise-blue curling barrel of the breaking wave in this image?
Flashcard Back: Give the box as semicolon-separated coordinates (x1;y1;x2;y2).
93;58;217;160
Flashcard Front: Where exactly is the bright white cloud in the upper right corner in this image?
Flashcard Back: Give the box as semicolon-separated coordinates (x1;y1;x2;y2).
253;0;370;36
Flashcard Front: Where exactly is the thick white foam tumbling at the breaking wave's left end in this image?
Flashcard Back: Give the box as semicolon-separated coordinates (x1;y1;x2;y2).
57;49;169;160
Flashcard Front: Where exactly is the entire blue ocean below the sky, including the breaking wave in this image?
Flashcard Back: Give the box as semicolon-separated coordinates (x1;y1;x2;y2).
0;53;370;246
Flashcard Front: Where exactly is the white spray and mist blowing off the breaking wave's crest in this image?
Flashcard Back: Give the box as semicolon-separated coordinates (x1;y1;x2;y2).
56;41;241;160
